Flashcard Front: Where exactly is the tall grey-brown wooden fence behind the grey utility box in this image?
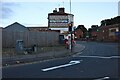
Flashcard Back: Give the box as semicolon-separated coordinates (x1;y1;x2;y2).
2;31;59;48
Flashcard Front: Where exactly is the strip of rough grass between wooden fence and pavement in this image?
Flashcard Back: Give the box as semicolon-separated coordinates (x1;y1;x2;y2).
2;45;65;56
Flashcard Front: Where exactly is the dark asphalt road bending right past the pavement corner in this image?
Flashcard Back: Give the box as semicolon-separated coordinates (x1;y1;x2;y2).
2;41;120;80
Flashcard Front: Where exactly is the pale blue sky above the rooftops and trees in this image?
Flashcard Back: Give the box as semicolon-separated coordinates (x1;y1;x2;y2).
0;0;119;29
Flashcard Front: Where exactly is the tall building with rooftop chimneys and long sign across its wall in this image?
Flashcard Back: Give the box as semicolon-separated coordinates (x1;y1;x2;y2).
48;8;74;28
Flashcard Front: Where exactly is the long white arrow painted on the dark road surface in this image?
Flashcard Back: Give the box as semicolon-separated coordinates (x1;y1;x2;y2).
41;60;82;71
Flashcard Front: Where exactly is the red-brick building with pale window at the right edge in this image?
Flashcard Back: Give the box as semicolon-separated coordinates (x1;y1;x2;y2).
97;24;120;41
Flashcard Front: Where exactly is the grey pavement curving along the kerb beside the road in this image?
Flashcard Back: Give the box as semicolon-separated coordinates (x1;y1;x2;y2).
2;44;85;67
